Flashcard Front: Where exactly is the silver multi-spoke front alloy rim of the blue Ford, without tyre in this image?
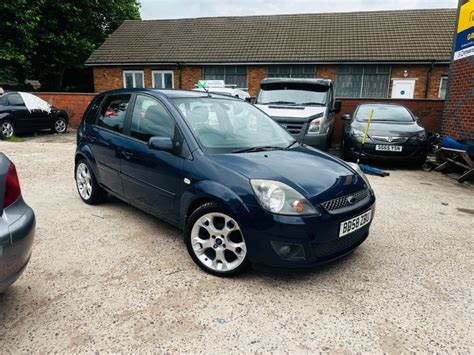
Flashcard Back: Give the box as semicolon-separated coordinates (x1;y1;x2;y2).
191;212;247;272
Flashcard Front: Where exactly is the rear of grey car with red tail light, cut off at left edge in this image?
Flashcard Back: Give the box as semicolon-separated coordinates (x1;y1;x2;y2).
0;153;35;292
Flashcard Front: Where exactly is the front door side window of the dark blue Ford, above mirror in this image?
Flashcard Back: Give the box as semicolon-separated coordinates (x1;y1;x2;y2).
130;95;176;142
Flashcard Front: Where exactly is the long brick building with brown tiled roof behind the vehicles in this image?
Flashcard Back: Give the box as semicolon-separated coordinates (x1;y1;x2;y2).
86;9;456;99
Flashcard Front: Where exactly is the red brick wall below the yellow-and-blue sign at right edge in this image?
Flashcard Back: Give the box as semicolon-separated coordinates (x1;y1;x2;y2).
441;56;474;139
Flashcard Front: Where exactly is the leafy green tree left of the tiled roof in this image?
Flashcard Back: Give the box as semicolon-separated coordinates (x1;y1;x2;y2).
0;0;140;90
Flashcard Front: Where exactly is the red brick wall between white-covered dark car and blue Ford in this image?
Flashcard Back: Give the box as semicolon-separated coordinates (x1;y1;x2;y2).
35;92;95;128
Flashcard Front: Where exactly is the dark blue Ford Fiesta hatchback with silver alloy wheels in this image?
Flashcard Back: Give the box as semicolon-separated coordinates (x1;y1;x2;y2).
75;89;375;276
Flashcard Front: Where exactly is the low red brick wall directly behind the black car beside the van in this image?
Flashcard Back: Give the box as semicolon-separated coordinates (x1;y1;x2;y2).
333;99;444;144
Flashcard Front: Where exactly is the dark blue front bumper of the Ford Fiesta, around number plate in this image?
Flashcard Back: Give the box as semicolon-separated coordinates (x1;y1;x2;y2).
239;193;375;268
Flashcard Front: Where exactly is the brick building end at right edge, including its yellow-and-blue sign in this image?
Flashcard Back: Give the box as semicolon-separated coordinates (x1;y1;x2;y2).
441;0;474;139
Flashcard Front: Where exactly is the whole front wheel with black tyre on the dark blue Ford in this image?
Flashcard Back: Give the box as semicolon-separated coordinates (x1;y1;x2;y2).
184;203;249;277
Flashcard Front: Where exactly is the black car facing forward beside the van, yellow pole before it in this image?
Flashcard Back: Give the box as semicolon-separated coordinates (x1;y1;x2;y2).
342;103;428;165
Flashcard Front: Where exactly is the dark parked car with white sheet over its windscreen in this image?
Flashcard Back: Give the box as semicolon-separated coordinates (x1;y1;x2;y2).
0;92;69;138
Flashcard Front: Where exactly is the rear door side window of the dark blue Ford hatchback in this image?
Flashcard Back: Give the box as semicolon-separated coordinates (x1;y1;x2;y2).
97;95;131;133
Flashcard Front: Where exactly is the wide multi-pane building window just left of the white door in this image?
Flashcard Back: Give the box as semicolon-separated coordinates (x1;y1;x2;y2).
336;65;390;98
